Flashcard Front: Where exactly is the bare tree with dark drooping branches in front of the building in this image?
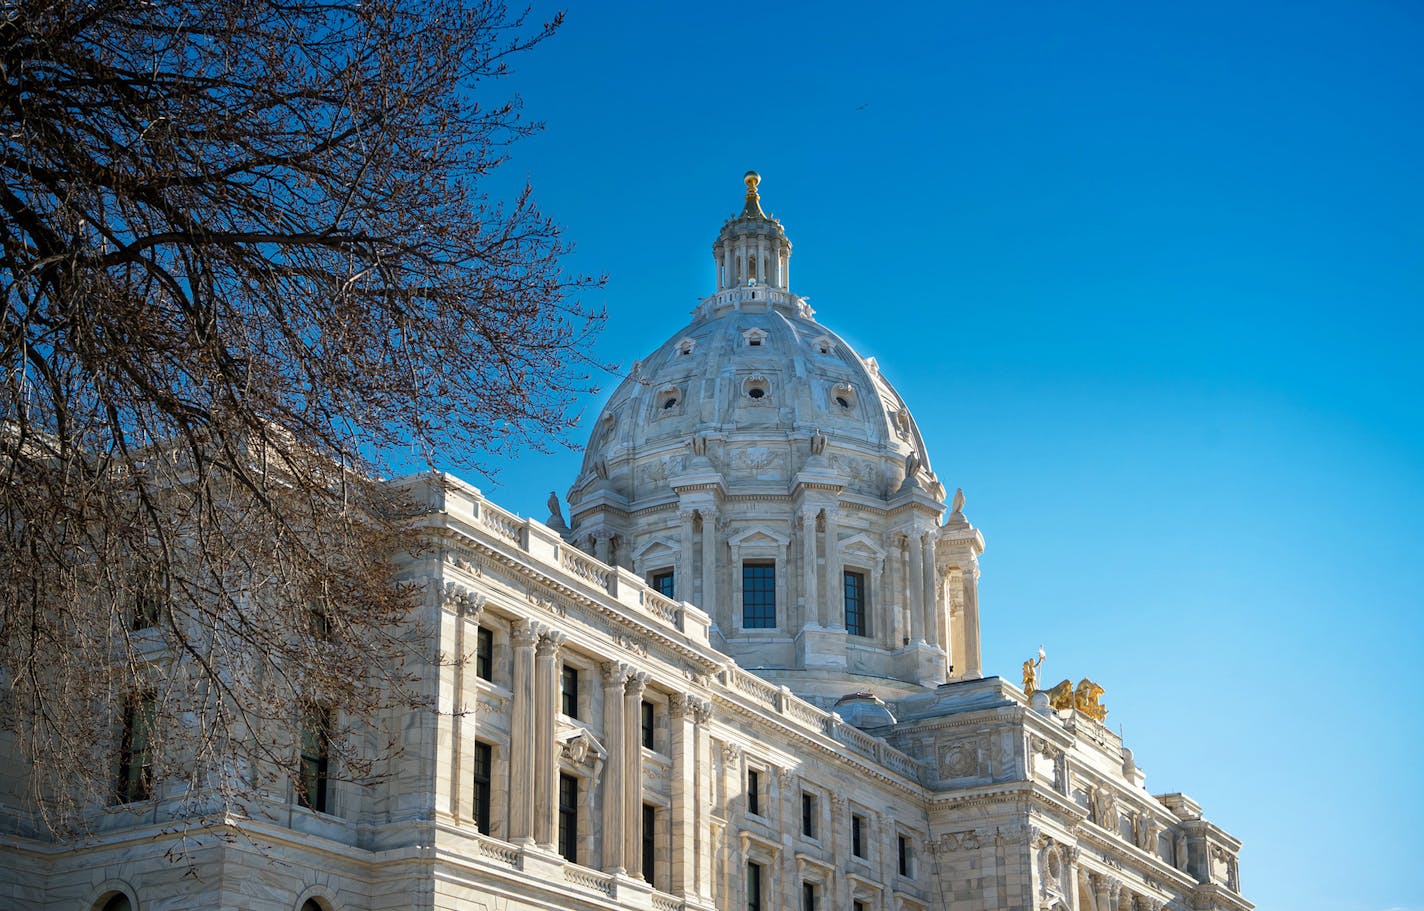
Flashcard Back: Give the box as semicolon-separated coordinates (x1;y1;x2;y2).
0;0;601;830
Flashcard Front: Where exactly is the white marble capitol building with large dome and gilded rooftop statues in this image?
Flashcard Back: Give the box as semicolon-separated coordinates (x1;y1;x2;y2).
0;174;1253;911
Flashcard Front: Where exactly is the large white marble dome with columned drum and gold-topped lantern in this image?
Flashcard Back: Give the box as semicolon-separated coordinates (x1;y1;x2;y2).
568;172;984;705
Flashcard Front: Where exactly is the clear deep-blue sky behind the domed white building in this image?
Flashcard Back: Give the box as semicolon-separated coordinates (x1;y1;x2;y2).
447;0;1424;911
